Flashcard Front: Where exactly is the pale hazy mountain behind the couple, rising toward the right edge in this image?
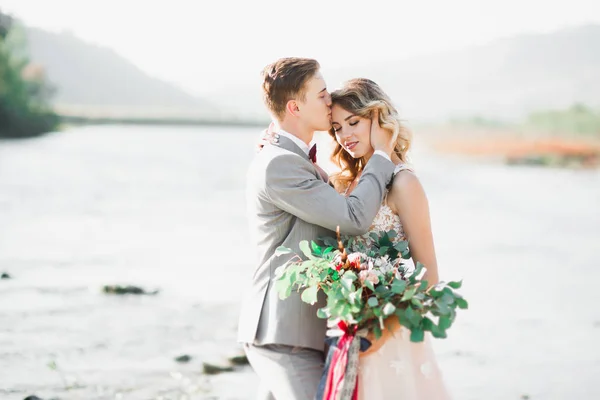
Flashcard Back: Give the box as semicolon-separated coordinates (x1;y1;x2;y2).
211;25;600;120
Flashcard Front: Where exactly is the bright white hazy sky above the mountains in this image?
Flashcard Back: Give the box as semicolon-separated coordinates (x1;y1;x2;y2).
1;0;600;94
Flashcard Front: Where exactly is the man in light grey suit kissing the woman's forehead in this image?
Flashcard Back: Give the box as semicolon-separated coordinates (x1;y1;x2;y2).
238;58;394;400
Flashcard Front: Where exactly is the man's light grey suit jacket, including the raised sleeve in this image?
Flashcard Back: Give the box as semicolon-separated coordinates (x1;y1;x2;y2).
238;136;394;350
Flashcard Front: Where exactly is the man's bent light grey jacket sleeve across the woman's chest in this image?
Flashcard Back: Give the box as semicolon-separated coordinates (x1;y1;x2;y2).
266;154;394;235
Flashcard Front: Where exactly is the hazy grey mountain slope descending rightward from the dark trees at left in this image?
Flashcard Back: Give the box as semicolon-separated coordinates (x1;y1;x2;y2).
26;28;215;113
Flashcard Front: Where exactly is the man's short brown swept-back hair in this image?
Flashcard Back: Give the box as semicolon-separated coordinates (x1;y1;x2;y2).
262;57;320;119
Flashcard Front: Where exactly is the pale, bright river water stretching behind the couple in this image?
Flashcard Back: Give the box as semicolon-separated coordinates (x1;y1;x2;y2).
0;126;600;400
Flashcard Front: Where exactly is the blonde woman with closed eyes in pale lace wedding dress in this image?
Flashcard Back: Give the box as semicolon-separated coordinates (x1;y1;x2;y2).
329;79;450;400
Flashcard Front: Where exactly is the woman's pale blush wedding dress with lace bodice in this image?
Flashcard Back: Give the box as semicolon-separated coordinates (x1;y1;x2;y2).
346;164;450;400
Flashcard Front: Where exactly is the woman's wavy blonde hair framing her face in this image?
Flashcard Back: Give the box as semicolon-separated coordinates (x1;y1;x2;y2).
329;78;411;190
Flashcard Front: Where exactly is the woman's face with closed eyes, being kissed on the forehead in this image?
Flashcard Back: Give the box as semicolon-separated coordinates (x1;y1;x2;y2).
331;104;373;158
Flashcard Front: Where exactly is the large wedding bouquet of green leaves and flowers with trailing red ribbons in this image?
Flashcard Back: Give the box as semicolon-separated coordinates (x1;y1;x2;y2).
276;229;468;399
